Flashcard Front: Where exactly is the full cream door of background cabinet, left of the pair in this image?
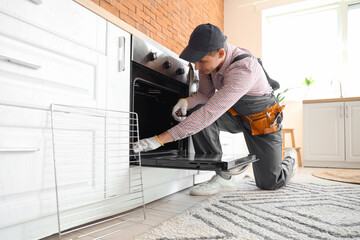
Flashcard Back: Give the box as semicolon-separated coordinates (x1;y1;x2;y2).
303;102;345;163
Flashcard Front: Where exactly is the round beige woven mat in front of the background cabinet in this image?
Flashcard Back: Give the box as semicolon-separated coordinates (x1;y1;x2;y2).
312;169;360;184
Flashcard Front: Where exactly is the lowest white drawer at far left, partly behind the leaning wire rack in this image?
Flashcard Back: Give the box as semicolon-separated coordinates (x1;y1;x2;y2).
0;105;56;228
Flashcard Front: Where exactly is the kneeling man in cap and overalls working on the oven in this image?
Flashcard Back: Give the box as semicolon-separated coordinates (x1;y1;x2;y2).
134;24;297;195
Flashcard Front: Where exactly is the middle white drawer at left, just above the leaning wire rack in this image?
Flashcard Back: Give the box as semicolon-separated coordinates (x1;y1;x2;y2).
0;13;106;107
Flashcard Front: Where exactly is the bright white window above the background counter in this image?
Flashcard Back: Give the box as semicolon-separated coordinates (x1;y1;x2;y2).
262;0;360;100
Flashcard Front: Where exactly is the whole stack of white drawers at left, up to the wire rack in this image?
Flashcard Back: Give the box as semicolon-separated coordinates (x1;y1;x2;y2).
0;0;107;239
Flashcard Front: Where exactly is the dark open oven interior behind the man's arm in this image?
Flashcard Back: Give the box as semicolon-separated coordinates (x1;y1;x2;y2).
131;62;188;155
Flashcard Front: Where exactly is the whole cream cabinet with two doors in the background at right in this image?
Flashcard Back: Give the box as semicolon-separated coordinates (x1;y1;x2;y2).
303;98;360;168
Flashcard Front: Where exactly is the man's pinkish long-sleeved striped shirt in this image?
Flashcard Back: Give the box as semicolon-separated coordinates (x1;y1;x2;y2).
168;44;272;141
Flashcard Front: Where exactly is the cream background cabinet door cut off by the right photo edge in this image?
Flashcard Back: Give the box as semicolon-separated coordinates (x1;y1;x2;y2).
345;101;360;162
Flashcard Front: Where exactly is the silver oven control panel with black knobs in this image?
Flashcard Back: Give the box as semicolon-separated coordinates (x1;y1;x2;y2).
131;35;189;84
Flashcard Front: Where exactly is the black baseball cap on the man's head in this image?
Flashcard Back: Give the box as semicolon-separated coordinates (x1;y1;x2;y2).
180;23;227;63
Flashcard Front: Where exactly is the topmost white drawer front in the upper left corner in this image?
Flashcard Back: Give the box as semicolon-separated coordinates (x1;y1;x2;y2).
0;0;106;53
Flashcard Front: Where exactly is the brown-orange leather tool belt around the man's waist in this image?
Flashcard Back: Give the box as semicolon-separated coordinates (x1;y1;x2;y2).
228;104;285;135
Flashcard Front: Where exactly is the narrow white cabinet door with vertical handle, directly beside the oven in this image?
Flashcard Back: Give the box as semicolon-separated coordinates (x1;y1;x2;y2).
105;22;131;198
